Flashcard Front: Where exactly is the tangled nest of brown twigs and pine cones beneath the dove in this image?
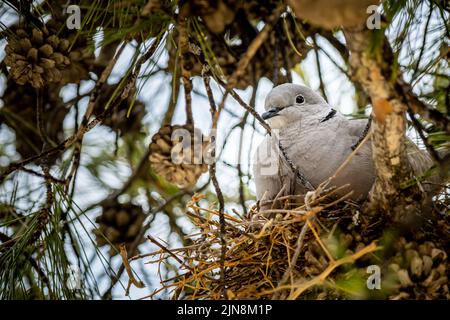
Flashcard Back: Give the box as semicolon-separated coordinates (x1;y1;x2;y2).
131;182;450;299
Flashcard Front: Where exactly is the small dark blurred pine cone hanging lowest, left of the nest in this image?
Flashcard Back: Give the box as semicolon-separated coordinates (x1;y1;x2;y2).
94;203;145;256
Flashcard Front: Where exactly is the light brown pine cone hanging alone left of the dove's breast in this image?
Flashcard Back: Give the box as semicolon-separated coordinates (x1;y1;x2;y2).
149;125;210;188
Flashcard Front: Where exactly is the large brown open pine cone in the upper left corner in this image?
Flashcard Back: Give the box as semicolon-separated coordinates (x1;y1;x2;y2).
4;20;95;88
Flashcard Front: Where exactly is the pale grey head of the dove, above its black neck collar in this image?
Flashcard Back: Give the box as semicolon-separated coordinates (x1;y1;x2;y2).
262;83;331;129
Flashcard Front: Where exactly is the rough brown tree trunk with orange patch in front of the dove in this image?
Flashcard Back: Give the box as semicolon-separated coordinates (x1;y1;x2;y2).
344;28;422;223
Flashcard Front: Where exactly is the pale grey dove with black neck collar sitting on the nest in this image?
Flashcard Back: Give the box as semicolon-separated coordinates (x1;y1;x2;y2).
253;84;433;206
